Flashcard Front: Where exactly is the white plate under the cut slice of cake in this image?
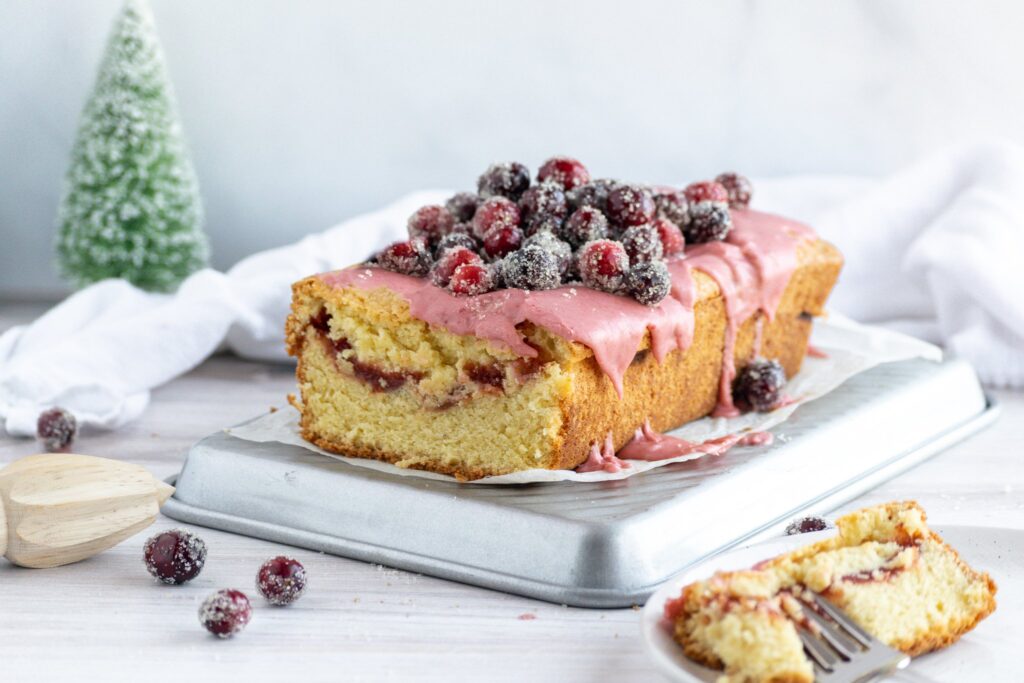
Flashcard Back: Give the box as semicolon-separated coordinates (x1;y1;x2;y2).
640;526;1024;683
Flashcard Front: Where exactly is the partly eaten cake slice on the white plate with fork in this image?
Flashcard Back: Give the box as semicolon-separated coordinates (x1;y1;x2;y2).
665;502;995;683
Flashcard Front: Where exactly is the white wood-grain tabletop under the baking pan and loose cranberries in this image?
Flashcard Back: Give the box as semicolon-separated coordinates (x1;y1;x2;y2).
0;304;1024;683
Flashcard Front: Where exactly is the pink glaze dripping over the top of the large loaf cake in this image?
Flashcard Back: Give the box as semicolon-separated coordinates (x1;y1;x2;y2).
321;210;814;415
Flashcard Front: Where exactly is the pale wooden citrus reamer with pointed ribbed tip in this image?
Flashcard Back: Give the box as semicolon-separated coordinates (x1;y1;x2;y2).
0;454;174;567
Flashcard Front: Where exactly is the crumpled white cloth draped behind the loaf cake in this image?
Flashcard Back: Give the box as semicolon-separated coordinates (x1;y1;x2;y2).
0;143;1024;434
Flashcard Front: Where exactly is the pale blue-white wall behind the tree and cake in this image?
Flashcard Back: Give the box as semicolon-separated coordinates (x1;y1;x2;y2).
0;0;1024;297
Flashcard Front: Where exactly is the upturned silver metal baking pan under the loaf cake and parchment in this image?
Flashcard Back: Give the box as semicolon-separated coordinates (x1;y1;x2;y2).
163;360;997;607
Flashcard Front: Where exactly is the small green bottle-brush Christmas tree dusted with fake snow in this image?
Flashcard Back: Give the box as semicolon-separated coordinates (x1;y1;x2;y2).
56;0;209;291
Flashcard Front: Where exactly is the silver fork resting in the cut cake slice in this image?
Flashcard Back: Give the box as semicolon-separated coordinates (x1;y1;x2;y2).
798;591;910;683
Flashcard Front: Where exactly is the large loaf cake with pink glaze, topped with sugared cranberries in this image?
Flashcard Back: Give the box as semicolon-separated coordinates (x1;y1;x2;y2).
287;157;842;480
